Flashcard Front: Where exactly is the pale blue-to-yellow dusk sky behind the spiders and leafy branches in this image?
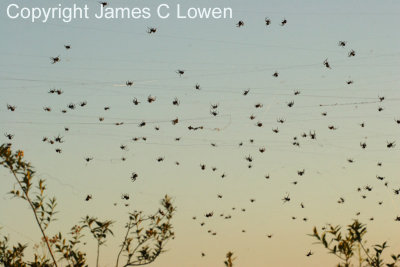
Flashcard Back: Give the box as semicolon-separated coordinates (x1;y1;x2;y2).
0;0;400;267
